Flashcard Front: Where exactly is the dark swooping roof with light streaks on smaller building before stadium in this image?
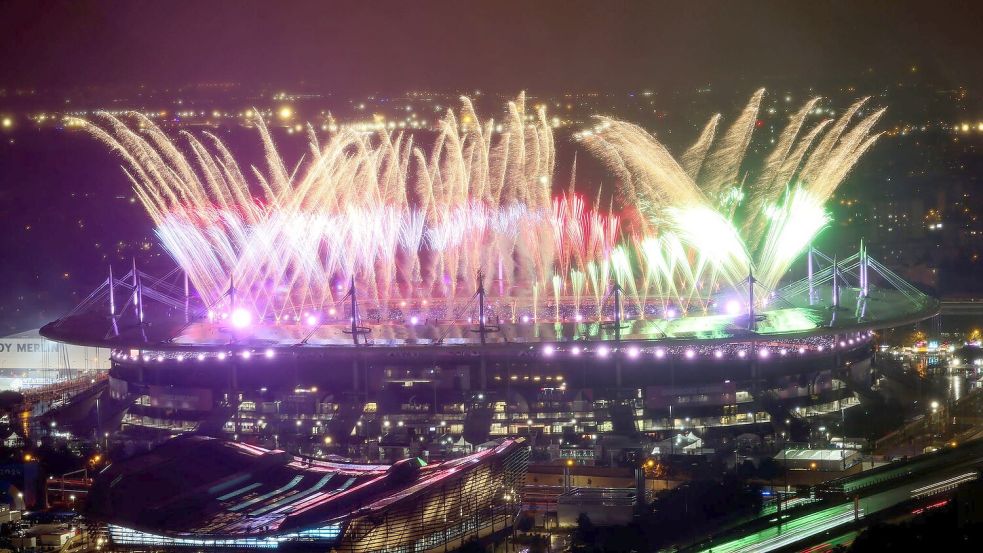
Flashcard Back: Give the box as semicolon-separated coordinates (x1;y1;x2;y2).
86;436;521;545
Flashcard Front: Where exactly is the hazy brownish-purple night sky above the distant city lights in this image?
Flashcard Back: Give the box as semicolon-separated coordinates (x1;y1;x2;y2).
0;0;983;94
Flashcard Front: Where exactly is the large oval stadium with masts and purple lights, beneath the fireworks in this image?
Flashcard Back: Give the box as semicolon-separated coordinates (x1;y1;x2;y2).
42;248;938;462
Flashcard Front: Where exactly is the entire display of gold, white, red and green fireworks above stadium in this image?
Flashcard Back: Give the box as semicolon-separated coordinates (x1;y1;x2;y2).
87;91;880;320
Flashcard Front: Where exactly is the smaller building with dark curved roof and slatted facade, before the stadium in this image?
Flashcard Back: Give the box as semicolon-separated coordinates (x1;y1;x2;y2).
86;436;528;552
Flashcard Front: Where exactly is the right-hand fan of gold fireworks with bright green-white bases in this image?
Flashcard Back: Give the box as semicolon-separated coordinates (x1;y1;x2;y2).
580;89;883;289
